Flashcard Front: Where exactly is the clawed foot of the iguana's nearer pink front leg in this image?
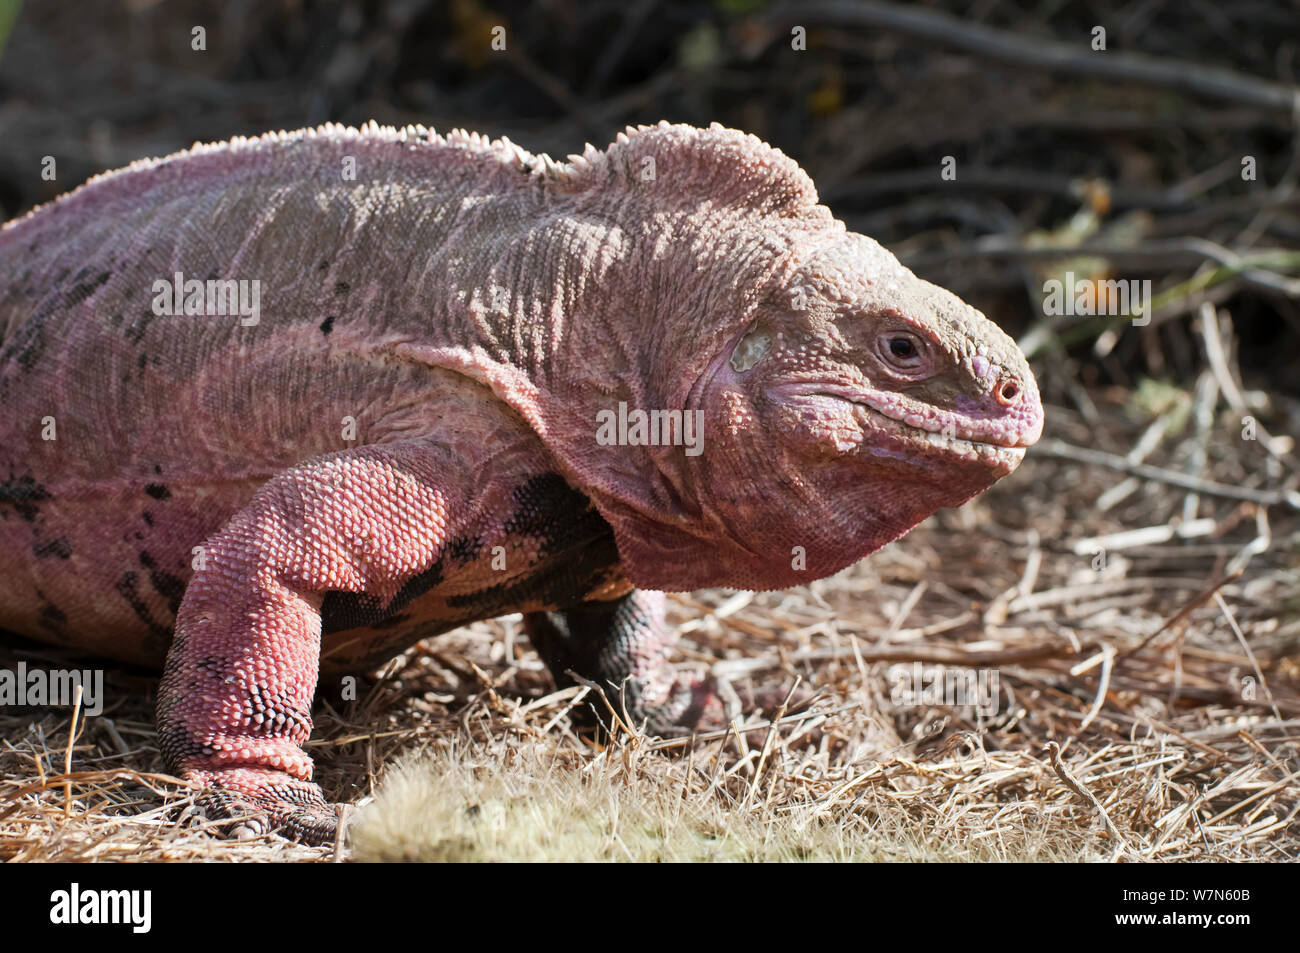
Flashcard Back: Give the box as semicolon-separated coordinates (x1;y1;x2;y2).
185;767;338;846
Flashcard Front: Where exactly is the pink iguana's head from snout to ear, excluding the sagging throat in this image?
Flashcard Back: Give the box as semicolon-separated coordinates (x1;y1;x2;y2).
728;233;1043;486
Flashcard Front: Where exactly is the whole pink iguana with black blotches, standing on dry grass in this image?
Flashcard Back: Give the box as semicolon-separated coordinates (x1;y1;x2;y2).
0;124;1043;842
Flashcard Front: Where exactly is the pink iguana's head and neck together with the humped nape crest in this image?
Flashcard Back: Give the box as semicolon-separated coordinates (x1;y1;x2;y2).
493;125;1043;589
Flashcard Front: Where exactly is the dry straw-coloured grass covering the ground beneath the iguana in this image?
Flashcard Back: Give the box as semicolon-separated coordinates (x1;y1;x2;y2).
0;379;1300;861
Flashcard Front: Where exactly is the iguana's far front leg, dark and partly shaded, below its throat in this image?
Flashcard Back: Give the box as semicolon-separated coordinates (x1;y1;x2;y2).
524;589;724;737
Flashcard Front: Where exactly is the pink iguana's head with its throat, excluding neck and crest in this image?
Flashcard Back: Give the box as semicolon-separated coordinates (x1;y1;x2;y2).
696;228;1043;585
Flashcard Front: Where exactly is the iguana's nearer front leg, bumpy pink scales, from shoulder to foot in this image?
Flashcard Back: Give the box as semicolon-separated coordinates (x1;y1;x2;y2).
157;443;462;844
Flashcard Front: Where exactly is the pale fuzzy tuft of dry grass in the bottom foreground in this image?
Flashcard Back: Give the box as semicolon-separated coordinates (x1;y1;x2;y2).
351;740;1079;862
